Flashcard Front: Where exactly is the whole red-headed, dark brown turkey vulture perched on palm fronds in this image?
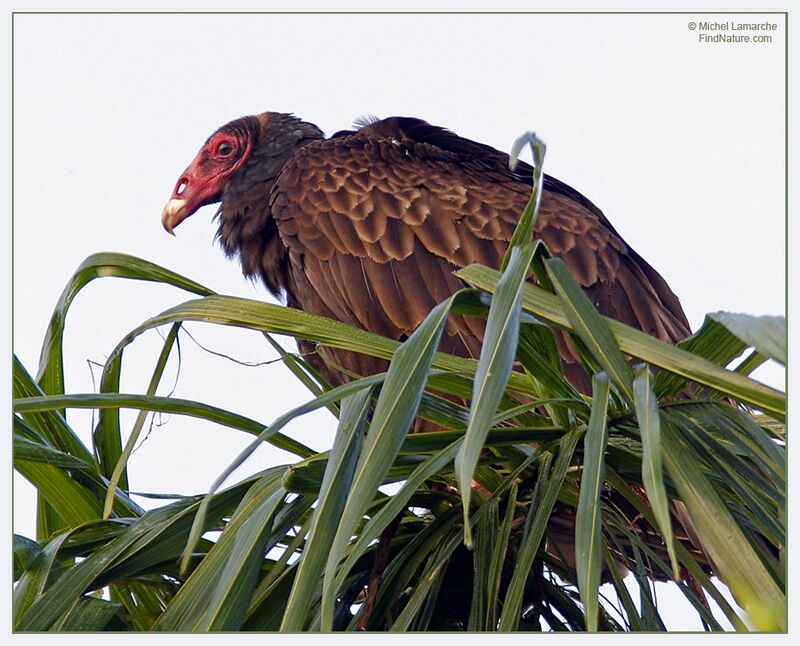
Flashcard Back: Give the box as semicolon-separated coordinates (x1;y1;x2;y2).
162;112;690;392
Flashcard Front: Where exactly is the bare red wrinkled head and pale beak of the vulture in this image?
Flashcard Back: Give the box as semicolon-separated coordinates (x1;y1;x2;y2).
161;117;262;235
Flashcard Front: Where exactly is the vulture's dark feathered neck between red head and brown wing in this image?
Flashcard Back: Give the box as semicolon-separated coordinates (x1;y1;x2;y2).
217;113;323;296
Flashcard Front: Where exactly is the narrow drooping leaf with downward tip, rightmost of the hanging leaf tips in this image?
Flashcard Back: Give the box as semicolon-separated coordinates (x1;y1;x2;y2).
633;364;680;580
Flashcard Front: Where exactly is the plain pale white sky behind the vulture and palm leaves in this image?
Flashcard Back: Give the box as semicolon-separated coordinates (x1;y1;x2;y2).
13;6;785;628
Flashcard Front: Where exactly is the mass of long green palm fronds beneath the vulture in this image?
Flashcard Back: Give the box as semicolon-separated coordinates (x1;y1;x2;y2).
13;211;787;631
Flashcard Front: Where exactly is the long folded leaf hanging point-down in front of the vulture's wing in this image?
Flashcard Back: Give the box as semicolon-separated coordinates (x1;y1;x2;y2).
456;243;534;548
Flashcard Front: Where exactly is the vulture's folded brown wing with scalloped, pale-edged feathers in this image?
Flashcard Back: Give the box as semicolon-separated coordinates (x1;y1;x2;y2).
270;118;689;389
